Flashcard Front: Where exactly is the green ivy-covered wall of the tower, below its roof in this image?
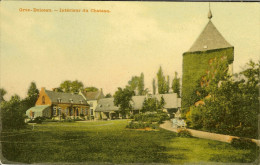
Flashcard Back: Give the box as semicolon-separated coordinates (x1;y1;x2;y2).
182;47;234;114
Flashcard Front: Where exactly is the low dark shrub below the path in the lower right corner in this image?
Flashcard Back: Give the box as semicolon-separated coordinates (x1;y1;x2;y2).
231;138;257;149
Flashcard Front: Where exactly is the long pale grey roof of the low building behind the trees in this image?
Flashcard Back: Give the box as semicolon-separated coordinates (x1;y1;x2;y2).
95;93;181;112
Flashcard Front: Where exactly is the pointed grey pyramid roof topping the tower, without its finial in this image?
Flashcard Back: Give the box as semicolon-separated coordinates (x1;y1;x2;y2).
188;20;233;52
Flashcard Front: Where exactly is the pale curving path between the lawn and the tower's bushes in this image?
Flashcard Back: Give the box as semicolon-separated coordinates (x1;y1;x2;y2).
160;121;260;146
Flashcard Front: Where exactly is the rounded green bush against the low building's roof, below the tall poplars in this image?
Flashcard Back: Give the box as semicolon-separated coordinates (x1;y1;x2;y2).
141;96;165;113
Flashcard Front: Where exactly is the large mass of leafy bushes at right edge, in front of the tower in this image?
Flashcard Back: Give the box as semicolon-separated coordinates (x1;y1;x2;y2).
187;61;260;138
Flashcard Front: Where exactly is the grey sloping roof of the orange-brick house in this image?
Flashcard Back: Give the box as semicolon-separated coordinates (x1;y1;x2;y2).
45;90;88;104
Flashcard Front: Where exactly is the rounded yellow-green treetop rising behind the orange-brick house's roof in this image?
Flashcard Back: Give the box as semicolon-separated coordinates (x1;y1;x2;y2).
59;80;84;93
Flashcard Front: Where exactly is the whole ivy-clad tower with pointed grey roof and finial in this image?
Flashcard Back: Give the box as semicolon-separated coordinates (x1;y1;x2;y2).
182;9;234;114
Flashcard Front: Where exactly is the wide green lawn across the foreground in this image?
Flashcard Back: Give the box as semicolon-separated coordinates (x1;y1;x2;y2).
1;120;257;163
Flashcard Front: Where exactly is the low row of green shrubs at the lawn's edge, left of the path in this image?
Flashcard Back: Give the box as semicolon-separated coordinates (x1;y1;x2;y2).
134;112;169;124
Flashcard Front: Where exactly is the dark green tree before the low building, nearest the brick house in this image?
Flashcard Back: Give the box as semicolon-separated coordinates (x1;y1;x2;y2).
114;88;134;118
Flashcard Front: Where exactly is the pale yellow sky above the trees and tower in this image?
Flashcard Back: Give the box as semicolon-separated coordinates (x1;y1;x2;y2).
0;1;260;99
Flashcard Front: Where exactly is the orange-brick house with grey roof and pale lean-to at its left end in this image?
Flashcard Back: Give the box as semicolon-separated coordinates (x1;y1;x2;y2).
26;88;89;120
